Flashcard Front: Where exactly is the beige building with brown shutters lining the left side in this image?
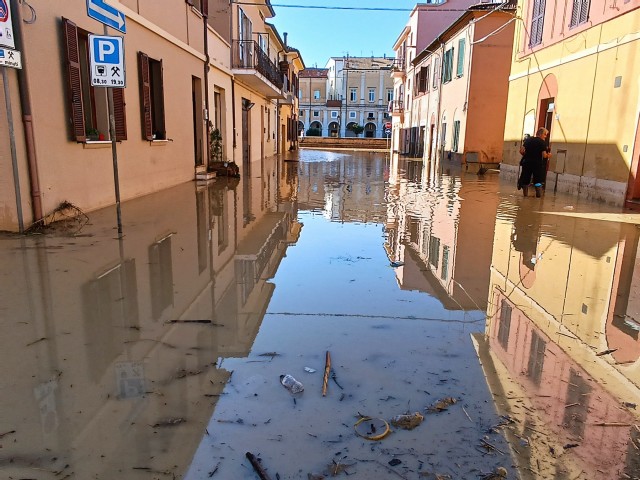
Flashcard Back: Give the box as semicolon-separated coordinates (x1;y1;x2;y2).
0;0;304;231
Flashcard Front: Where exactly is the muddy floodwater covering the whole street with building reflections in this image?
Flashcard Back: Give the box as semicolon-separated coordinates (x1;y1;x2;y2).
0;150;640;480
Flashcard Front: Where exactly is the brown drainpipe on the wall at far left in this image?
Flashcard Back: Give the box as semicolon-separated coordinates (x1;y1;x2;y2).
11;0;44;222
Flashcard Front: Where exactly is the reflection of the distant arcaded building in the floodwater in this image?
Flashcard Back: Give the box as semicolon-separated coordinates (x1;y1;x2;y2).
298;150;387;223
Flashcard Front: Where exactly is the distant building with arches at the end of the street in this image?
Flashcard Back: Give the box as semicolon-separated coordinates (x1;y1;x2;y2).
299;56;393;138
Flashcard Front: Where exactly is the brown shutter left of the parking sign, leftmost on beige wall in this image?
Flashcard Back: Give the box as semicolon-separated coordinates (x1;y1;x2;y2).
62;18;87;142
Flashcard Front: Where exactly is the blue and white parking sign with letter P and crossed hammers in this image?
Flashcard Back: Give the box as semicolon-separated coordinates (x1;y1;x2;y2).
89;35;126;88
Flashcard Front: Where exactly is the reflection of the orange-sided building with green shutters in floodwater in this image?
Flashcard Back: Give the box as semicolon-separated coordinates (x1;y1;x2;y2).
385;156;497;310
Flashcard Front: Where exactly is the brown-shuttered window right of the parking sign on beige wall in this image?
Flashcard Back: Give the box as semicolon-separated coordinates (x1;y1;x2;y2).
138;52;167;140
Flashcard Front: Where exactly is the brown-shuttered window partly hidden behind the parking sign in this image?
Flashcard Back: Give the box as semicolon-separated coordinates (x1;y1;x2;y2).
62;18;127;142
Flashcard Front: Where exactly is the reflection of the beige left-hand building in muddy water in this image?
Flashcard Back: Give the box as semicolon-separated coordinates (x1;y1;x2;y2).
0;156;299;479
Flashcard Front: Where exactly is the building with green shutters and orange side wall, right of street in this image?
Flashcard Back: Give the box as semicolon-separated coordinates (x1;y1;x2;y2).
397;4;515;168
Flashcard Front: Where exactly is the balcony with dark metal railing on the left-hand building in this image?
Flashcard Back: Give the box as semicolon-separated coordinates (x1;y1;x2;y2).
231;40;284;99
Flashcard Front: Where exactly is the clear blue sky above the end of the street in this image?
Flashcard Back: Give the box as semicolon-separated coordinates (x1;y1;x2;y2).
267;0;420;67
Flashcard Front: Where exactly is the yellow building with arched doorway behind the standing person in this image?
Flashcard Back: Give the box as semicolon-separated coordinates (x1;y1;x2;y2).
502;0;640;204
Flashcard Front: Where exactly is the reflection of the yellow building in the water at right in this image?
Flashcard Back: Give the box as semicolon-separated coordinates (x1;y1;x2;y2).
477;201;640;479
